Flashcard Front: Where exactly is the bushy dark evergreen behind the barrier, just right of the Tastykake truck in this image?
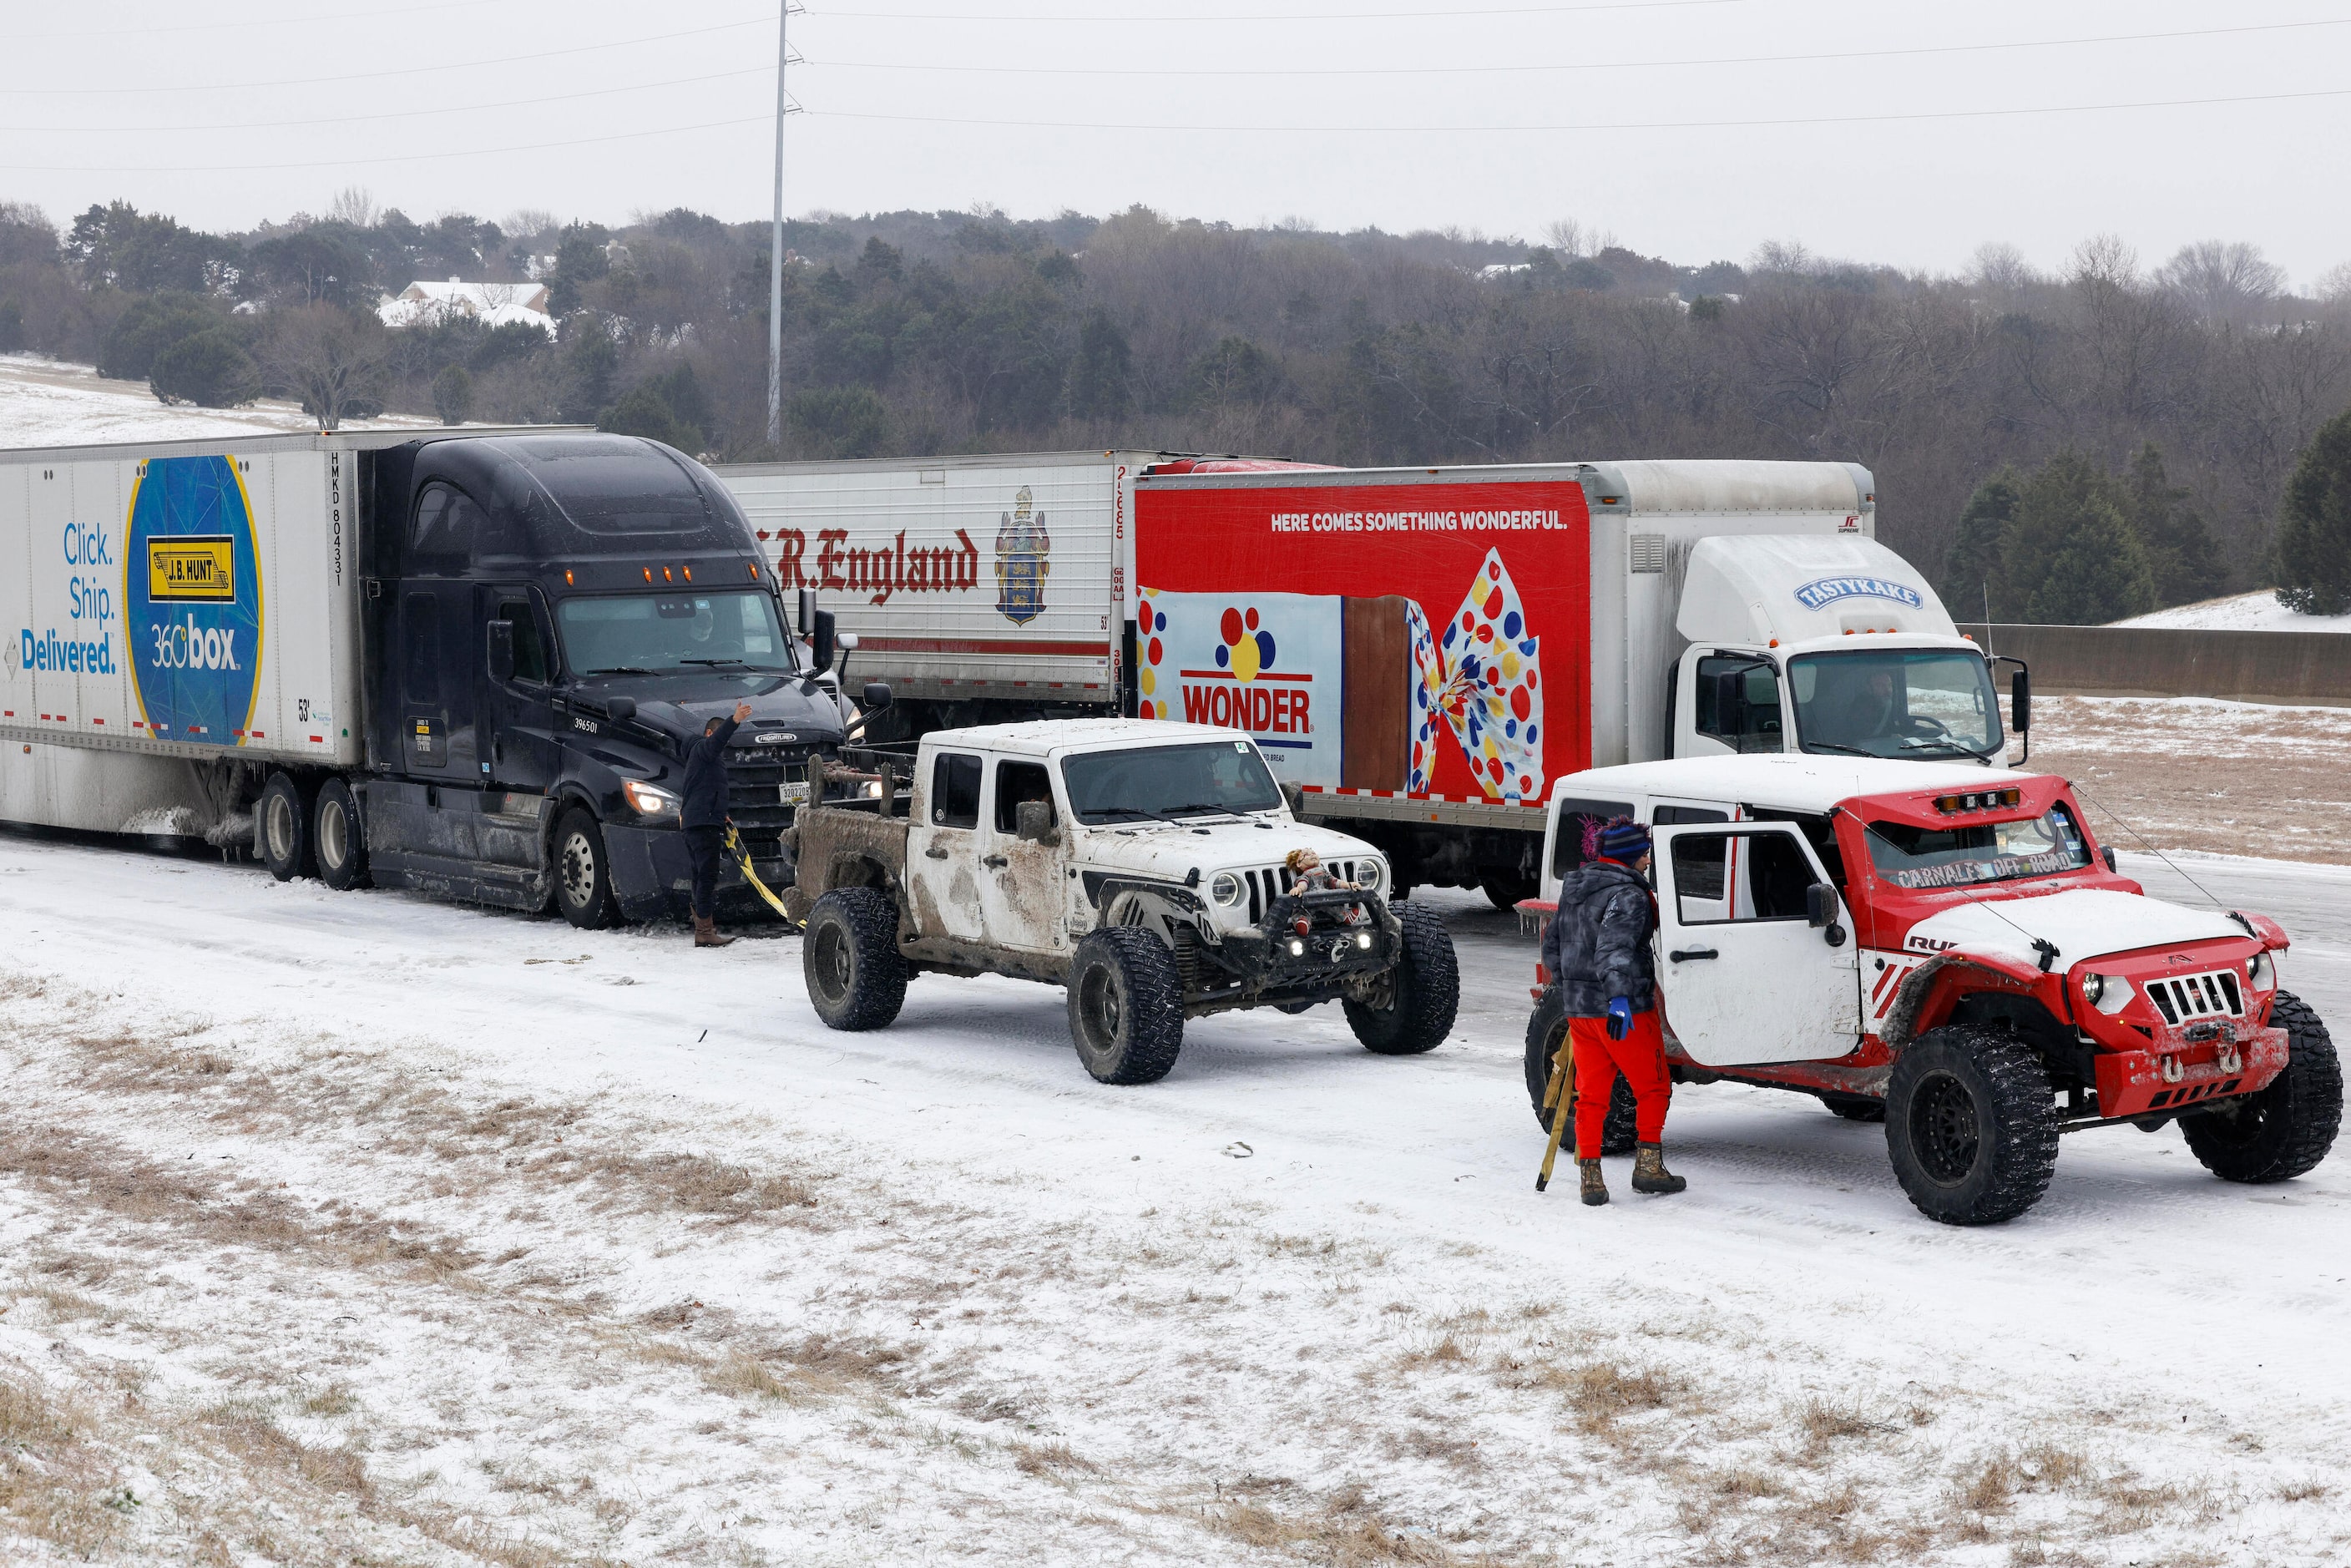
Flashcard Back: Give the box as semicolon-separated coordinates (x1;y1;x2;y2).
2000;452;2156;625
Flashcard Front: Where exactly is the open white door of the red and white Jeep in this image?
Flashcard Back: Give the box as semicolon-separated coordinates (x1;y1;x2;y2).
1655;822;1862;1067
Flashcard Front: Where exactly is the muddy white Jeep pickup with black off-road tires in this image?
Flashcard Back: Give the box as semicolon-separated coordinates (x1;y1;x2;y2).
786;720;1460;1084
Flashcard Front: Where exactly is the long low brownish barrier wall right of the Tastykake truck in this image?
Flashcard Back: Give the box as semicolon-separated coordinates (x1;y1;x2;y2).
1959;625;2351;706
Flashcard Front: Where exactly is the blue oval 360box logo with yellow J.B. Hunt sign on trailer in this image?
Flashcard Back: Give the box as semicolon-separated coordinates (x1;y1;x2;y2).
122;456;261;746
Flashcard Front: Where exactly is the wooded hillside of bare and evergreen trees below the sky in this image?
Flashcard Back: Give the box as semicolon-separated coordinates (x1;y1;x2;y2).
0;193;2351;619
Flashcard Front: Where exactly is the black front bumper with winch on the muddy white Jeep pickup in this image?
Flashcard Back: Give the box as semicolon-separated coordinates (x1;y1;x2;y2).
1178;888;1403;1009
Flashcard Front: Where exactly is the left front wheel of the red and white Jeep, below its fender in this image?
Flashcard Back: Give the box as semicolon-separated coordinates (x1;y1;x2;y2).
1885;1025;2057;1225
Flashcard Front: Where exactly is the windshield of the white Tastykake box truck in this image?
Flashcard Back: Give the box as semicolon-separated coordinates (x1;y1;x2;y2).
1787;649;2003;757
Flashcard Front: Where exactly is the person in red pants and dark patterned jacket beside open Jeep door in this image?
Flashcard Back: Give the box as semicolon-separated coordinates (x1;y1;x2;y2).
1542;818;1688;1204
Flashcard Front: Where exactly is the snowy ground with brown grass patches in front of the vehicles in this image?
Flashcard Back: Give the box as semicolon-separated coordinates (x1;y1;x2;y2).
0;832;2351;1568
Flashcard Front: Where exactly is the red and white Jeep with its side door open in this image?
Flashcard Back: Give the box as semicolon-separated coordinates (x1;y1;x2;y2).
1519;755;2342;1225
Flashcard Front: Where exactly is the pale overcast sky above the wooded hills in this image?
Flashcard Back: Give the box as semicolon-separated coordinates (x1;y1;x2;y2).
0;0;2351;287
